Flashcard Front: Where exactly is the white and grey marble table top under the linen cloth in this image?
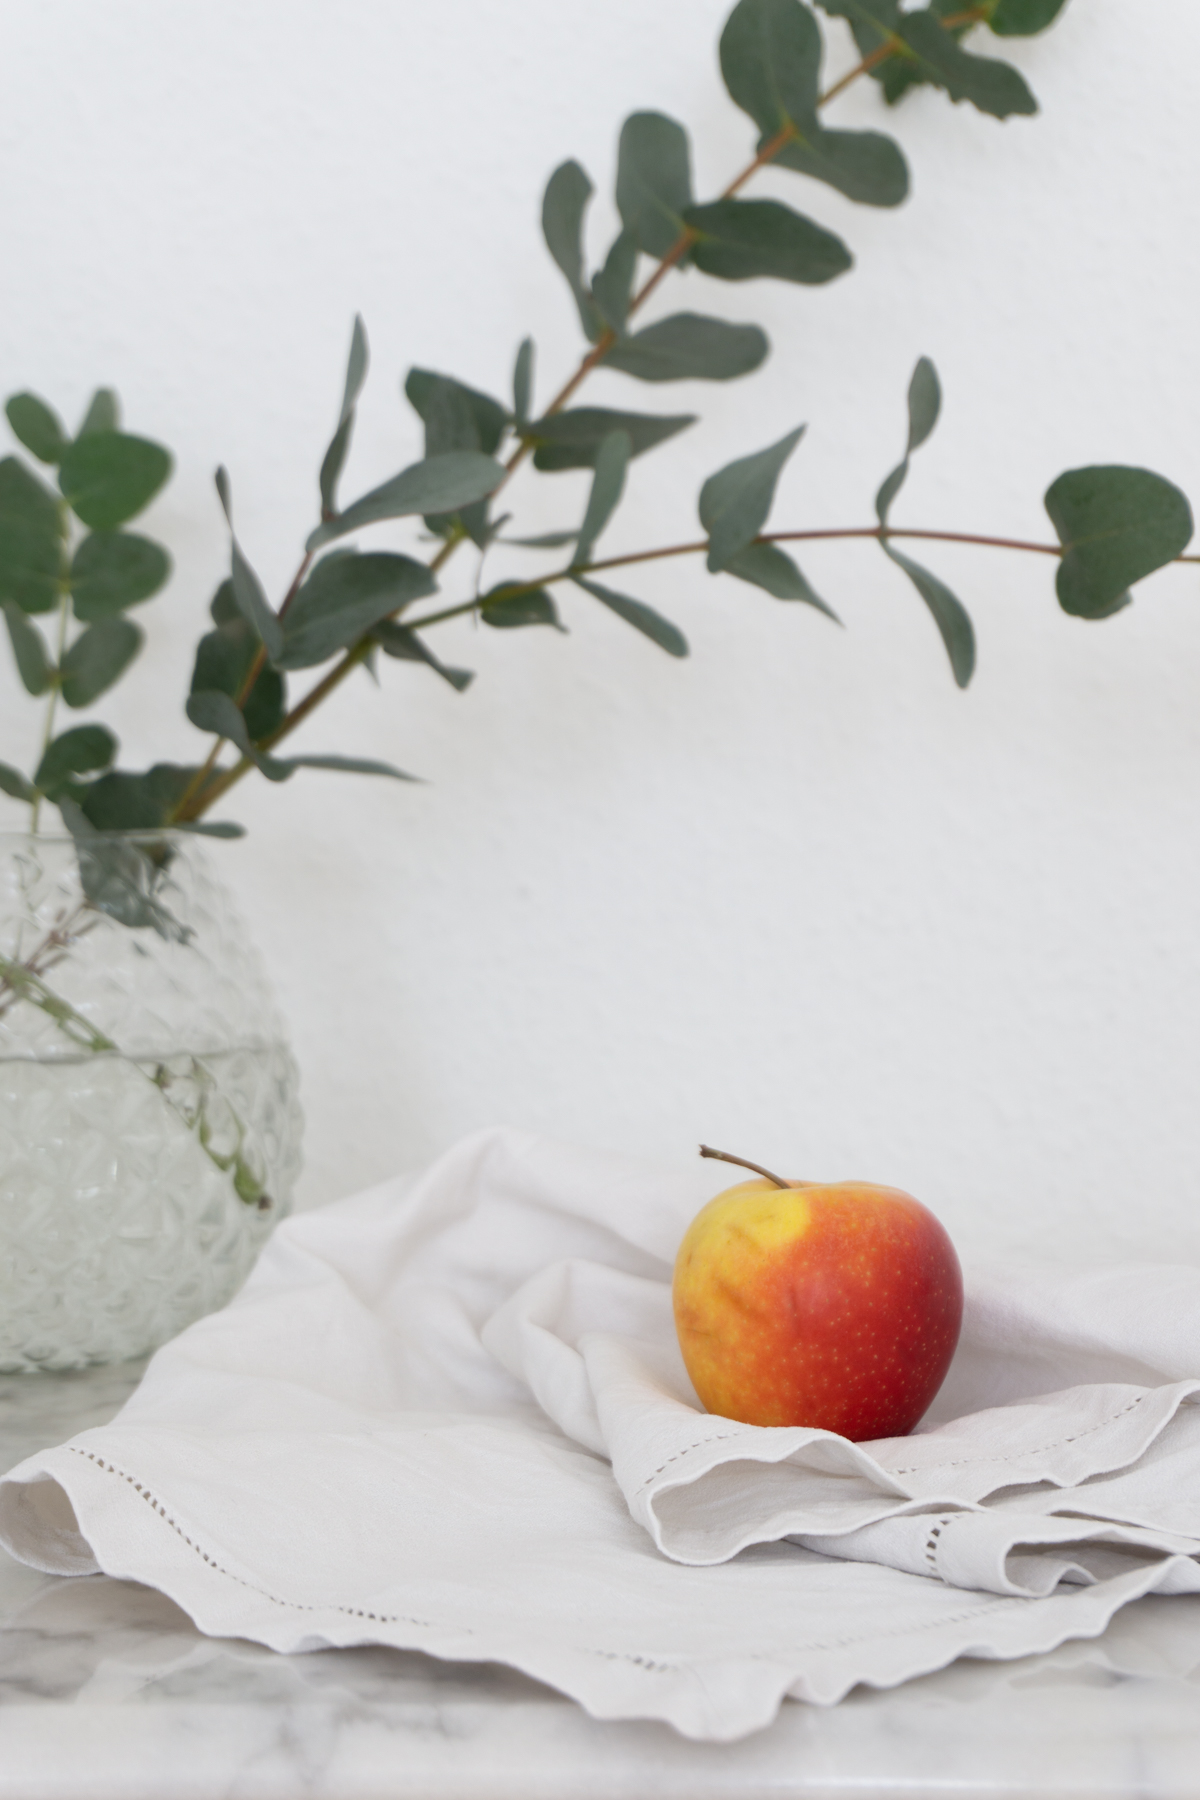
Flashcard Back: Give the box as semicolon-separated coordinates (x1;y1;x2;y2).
0;1364;1200;1800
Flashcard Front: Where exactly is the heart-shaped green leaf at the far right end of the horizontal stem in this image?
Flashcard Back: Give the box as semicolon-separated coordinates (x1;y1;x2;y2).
1045;466;1193;619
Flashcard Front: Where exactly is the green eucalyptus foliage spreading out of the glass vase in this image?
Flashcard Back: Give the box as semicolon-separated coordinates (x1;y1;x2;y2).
11;0;1165;867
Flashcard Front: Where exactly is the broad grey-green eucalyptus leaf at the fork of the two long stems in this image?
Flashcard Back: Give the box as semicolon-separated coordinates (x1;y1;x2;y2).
275;551;437;670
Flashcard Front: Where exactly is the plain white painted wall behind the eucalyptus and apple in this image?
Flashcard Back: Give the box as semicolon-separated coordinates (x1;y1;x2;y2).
0;0;1200;1256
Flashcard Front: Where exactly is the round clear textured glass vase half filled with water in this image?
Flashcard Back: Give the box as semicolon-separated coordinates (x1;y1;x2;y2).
0;832;302;1372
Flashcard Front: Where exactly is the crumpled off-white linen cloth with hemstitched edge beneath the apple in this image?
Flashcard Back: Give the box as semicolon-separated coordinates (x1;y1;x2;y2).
0;1130;1200;1739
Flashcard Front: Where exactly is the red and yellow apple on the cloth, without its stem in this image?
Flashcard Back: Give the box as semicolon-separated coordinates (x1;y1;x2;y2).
673;1181;963;1442
